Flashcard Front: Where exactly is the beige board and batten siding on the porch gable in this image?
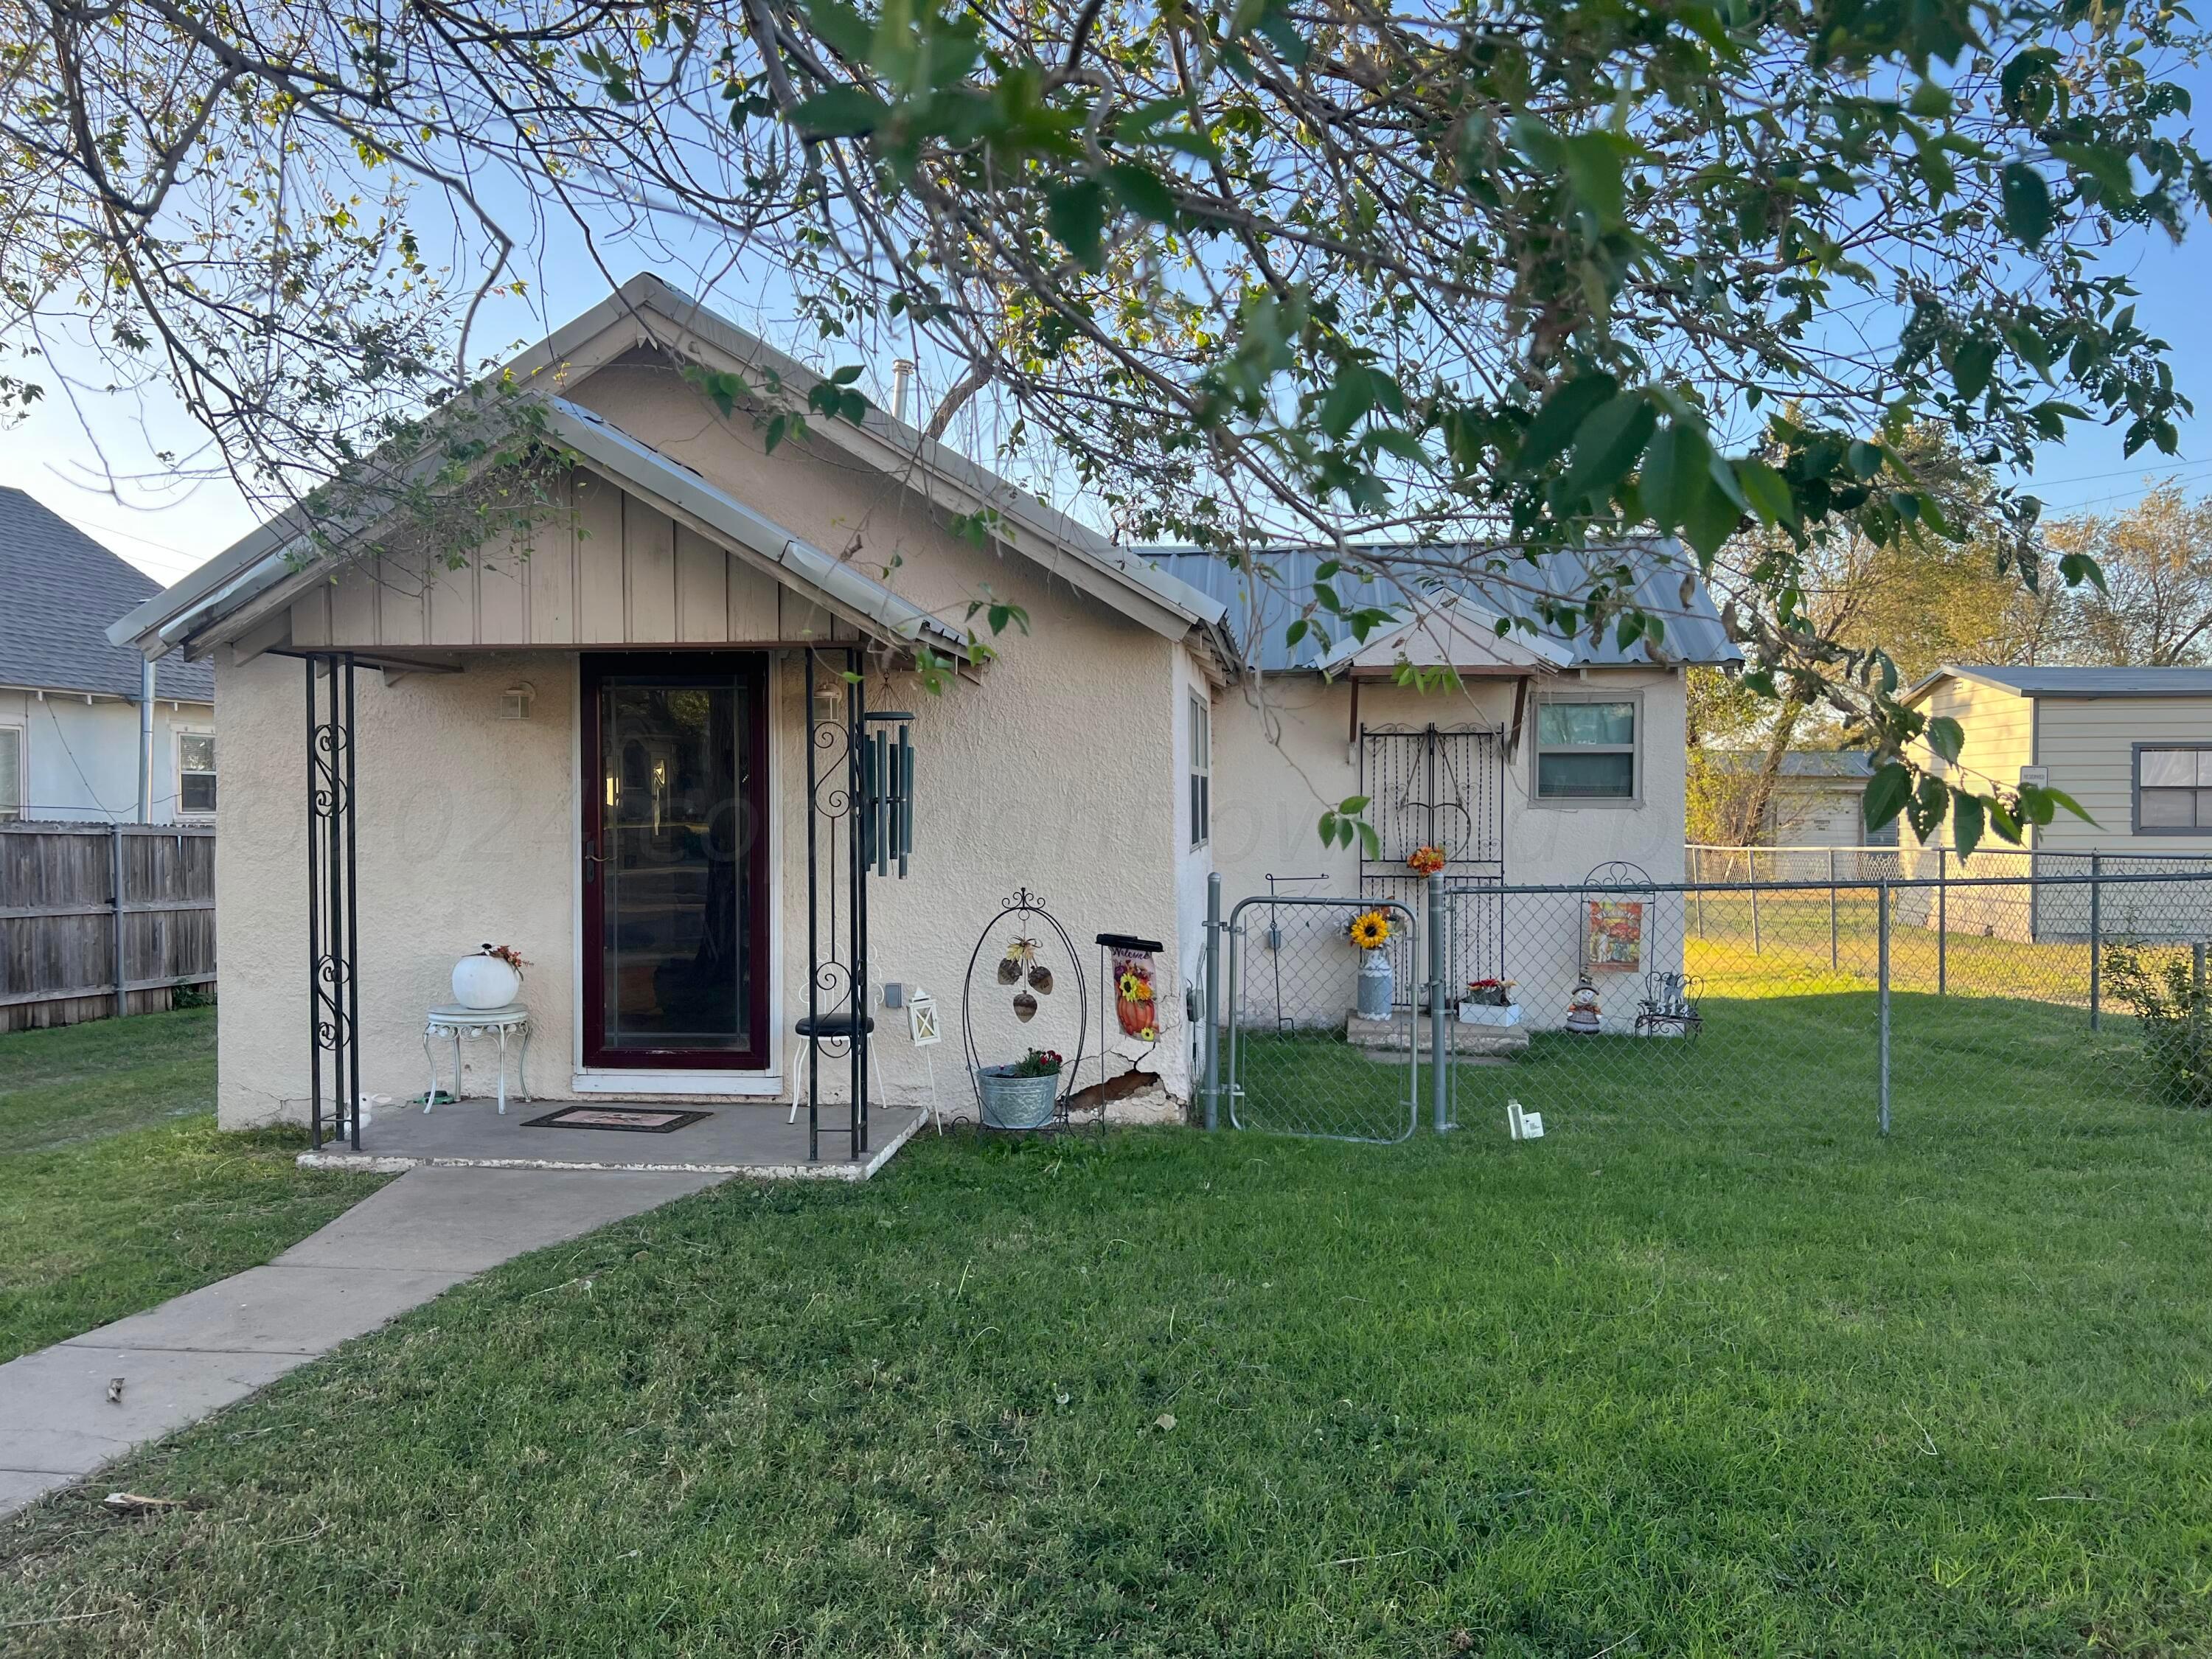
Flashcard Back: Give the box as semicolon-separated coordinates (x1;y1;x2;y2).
292;469;852;650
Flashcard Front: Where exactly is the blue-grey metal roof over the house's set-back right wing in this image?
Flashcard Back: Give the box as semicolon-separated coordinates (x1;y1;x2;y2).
1137;540;1743;672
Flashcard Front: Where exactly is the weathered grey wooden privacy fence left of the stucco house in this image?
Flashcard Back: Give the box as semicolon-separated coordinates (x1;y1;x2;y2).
0;823;215;1031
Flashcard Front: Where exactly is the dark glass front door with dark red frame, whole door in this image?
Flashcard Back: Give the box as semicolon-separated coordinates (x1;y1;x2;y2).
582;653;770;1071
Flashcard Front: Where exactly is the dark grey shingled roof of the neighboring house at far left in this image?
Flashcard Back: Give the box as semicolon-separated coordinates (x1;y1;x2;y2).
0;489;215;703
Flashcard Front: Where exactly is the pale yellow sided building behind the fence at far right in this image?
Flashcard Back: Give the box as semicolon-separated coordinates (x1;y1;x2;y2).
1905;666;2212;938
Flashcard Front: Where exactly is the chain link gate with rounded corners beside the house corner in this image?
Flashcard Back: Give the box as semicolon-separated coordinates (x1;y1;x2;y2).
1223;896;1427;1144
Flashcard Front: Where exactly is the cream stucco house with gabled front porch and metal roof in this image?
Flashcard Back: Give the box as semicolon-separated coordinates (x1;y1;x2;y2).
113;276;1734;1157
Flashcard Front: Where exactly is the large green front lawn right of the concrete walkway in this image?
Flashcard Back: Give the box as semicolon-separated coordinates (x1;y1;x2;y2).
0;1000;2212;1659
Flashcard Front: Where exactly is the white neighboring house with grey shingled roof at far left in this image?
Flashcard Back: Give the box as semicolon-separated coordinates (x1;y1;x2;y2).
0;489;217;823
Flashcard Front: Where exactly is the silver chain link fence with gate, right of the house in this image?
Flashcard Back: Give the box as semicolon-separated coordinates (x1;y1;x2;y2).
1223;872;2212;1141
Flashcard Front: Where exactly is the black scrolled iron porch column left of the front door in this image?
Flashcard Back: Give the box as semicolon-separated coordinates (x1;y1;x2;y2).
305;653;361;1152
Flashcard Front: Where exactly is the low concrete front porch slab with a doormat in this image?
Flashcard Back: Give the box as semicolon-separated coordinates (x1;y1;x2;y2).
299;1097;929;1181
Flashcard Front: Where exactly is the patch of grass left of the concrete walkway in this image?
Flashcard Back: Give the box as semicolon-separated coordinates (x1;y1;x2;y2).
0;1009;380;1360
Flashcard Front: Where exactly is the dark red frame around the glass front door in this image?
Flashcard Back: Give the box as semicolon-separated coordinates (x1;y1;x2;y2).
577;650;774;1071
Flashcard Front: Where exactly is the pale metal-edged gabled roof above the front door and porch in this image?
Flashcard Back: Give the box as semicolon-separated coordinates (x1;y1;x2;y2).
108;274;1223;655
